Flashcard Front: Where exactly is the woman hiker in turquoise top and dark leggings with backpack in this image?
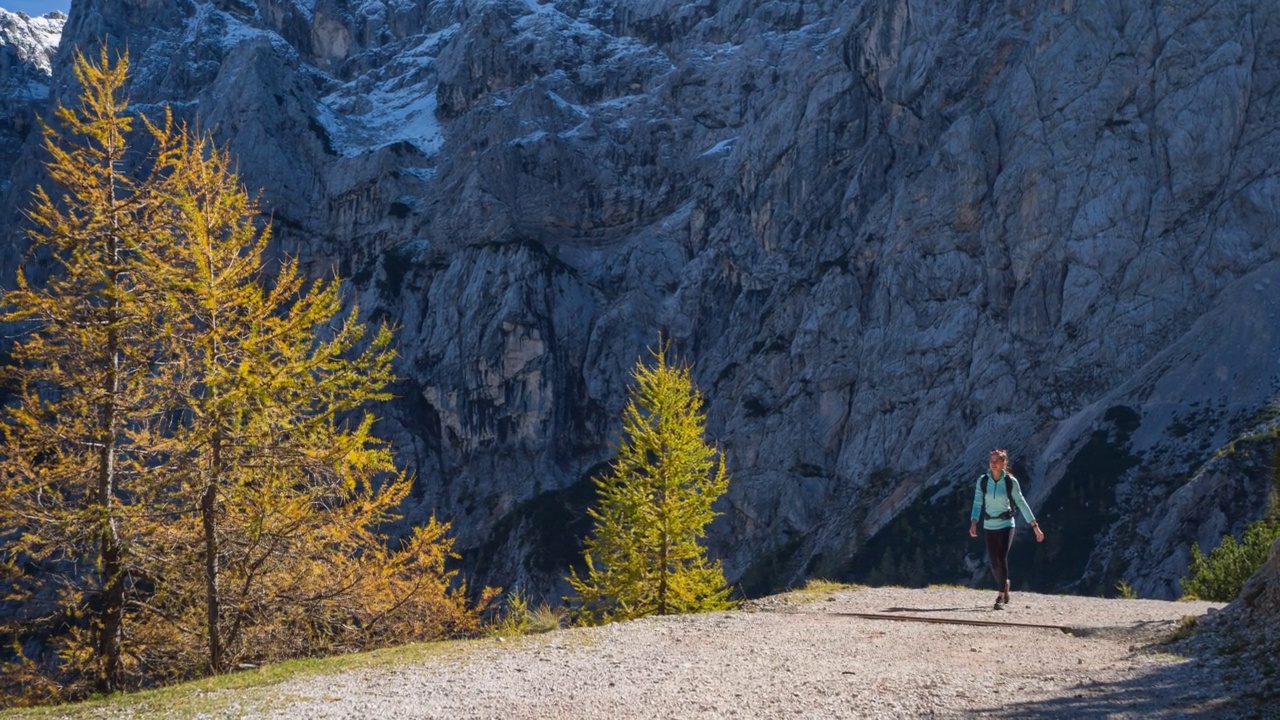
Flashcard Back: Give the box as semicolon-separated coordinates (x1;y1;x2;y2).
969;448;1044;610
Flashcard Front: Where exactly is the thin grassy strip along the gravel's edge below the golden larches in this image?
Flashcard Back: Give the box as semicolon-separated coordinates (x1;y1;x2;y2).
4;641;474;720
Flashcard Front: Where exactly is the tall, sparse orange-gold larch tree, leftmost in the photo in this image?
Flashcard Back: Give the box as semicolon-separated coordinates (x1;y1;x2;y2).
0;50;185;692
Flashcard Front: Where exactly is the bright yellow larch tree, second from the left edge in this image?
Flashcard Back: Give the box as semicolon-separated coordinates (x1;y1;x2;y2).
142;130;486;673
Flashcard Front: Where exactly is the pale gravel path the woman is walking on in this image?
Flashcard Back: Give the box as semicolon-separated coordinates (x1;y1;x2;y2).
235;588;1268;720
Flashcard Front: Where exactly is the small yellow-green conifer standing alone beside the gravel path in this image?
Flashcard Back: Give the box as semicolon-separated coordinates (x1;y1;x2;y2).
567;345;731;624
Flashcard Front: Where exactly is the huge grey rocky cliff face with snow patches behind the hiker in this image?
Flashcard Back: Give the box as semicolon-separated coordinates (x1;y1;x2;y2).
6;0;1280;597
